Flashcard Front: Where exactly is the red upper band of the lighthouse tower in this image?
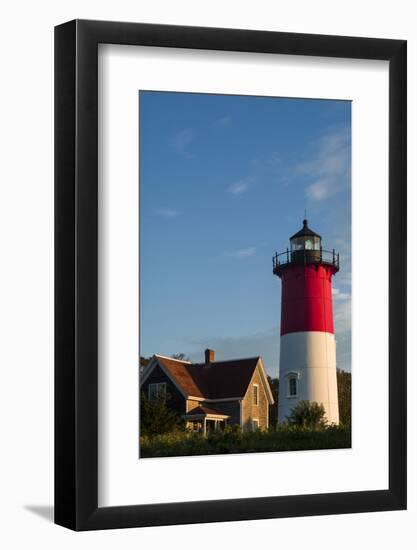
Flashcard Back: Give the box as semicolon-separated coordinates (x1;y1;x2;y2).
281;265;336;335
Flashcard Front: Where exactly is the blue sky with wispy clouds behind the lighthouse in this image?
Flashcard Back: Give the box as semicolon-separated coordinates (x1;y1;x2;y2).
139;92;351;376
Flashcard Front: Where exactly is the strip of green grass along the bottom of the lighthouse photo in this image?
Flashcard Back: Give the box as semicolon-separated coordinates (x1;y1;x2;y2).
140;426;351;458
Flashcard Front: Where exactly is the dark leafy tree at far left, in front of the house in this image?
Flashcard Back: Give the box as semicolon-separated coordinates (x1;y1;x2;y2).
140;392;185;437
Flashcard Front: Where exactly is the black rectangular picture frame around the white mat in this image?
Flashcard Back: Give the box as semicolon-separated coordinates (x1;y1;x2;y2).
55;20;407;531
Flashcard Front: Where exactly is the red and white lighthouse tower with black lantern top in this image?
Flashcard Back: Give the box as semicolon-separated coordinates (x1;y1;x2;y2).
273;220;339;424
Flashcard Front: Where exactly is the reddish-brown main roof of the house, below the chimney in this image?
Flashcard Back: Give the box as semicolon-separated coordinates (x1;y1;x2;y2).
145;355;270;399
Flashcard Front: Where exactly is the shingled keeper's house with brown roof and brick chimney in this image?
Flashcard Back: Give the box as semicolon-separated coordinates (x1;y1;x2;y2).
140;349;274;433
